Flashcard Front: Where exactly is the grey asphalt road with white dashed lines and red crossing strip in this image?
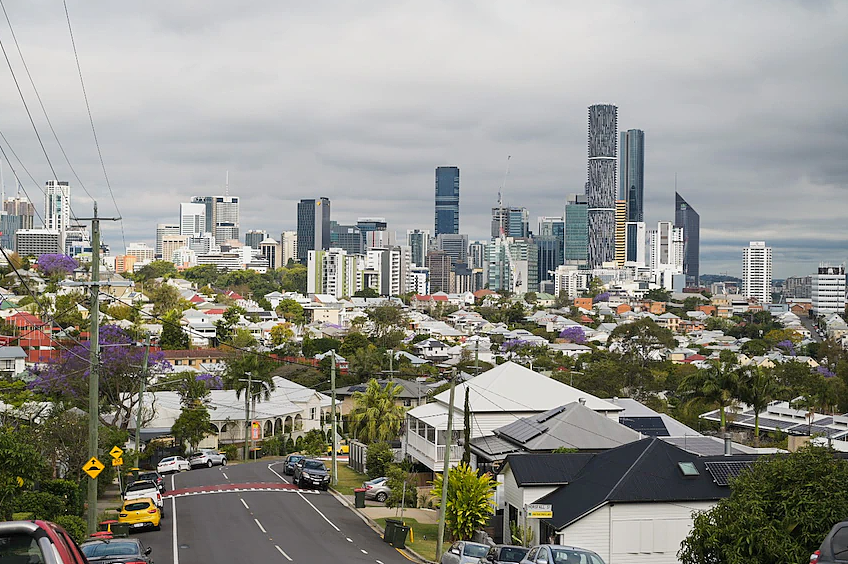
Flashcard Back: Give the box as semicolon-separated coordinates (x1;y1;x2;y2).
136;460;408;564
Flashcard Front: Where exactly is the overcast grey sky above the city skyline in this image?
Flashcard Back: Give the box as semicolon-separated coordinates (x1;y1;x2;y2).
0;0;848;277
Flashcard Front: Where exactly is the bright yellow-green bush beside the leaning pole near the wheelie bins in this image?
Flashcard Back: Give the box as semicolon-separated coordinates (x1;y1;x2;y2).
433;464;497;540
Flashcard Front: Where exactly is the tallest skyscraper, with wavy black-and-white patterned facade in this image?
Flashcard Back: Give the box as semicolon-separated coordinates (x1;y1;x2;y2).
586;104;618;268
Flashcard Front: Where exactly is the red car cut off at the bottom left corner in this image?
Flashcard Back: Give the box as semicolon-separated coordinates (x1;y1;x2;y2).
0;521;85;564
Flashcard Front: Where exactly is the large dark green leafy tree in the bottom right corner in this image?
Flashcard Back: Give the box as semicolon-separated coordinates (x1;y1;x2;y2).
678;446;848;564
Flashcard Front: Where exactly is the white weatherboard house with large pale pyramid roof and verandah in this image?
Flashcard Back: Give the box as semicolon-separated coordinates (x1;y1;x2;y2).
406;362;623;472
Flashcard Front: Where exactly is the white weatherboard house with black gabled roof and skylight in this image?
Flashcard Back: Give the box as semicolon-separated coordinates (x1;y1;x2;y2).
524;438;757;564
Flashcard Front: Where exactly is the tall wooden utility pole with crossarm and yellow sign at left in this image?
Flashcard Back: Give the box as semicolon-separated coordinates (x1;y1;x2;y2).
74;202;121;533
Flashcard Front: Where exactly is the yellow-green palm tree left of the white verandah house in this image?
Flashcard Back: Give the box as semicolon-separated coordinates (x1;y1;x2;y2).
350;379;406;443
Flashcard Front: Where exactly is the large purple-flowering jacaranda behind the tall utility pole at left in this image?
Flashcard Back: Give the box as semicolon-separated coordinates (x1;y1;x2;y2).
29;325;171;429
